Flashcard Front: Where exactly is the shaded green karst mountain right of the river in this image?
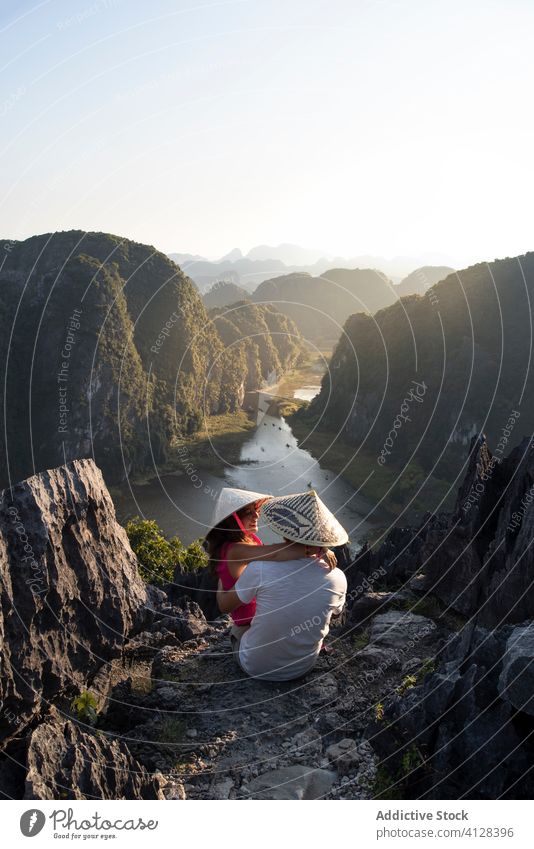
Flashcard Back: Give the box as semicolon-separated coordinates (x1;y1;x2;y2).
301;253;534;498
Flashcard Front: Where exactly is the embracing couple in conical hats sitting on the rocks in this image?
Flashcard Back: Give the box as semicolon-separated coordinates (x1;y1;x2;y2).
206;487;348;681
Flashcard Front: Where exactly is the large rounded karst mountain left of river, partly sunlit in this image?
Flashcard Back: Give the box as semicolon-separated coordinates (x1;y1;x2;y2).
0;231;304;490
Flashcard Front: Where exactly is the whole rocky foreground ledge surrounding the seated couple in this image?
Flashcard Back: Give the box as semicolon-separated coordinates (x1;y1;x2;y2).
0;439;534;800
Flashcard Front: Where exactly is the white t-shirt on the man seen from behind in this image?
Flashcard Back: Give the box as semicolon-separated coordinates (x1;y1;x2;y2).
234;557;347;681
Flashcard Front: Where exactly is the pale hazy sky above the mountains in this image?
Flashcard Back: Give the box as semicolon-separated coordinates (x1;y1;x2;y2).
0;0;534;266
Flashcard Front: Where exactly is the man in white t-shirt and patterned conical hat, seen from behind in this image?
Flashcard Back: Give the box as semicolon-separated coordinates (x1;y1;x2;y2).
217;490;348;681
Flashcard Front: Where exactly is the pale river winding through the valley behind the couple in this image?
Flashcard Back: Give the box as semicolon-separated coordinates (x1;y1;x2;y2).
114;385;372;544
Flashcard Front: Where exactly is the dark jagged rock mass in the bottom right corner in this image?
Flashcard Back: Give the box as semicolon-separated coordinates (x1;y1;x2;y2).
366;625;534;799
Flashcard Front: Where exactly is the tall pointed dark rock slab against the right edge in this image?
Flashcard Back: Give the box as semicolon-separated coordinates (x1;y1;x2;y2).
419;437;534;627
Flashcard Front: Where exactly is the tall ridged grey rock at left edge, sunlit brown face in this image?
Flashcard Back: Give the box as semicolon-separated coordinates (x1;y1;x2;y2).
0;460;147;739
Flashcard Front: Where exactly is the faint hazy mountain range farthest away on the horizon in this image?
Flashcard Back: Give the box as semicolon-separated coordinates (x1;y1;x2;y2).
168;244;456;293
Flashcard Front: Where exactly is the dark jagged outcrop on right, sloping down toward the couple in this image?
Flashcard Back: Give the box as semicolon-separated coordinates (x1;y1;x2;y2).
347;436;534;627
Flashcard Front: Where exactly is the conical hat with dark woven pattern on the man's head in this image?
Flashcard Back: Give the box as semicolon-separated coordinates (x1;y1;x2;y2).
261;489;349;547
